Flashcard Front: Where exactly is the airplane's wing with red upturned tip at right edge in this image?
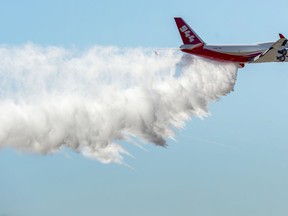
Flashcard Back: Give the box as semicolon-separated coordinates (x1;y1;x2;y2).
250;34;288;63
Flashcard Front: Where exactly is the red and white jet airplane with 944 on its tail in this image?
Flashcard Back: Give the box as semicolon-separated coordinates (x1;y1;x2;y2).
174;17;288;68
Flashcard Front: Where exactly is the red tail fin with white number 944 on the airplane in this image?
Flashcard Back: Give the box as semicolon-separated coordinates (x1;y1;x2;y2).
174;17;204;45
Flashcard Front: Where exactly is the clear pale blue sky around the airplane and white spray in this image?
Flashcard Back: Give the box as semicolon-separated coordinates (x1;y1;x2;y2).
0;0;288;216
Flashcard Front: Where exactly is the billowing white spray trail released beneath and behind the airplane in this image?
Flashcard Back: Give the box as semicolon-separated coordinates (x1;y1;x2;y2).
0;44;237;163
